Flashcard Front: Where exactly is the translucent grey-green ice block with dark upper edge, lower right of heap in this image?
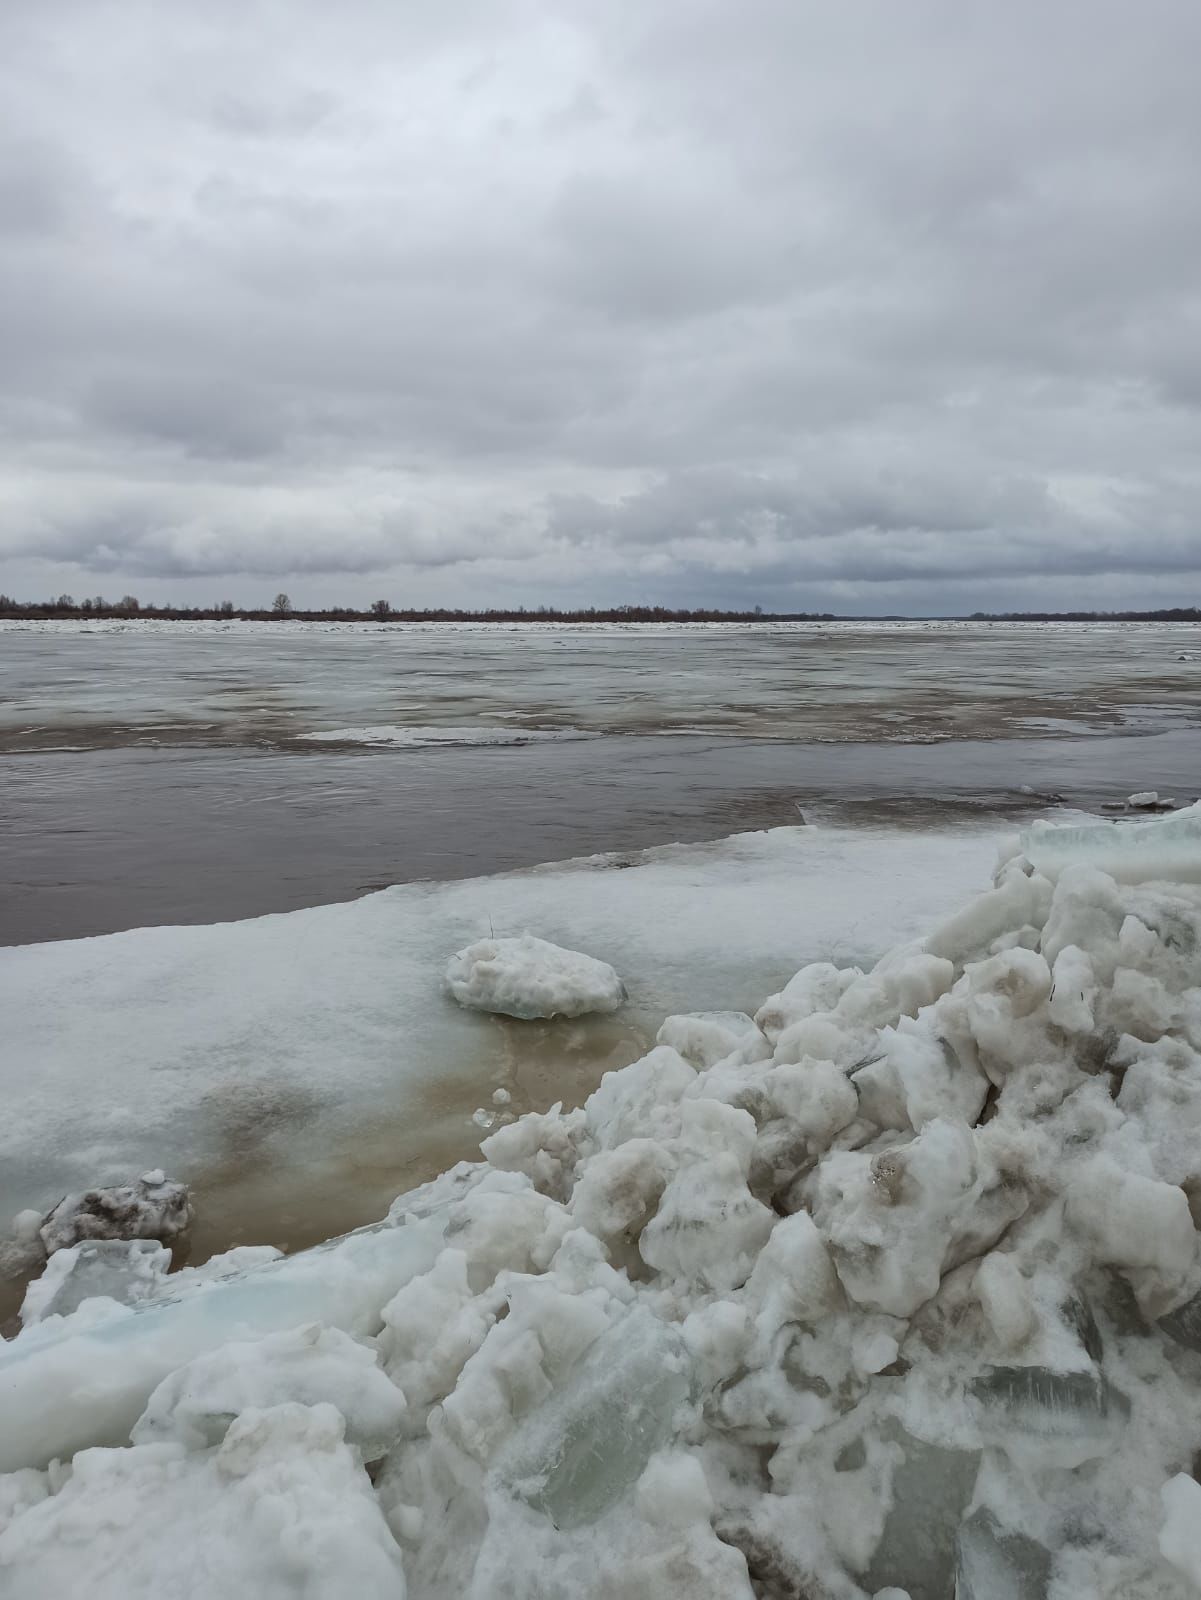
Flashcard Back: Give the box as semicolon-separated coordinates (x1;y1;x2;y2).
968;1366;1131;1467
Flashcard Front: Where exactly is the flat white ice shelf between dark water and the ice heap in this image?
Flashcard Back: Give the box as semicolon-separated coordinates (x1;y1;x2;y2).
0;827;996;1222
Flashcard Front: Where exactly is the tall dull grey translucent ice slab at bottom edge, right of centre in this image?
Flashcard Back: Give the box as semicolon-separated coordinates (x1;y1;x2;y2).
862;1424;980;1600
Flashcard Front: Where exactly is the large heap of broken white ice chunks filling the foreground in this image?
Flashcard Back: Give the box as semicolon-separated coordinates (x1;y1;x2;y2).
0;812;1201;1600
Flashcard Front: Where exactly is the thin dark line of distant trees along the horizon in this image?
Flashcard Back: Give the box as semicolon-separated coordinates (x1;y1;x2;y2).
0;592;1201;622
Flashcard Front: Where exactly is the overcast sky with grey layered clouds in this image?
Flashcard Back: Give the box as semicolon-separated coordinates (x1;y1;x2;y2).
0;0;1201;613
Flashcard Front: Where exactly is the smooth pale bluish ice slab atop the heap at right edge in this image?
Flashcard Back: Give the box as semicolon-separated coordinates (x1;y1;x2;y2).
1022;802;1201;883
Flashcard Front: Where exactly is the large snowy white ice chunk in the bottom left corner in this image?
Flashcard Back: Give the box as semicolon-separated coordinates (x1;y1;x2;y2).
0;1405;405;1600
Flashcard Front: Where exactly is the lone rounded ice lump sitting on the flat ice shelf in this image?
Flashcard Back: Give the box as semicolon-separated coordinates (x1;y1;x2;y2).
446;933;625;1021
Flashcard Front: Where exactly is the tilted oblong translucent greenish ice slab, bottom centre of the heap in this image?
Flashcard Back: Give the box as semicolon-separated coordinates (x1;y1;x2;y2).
496;1310;691;1528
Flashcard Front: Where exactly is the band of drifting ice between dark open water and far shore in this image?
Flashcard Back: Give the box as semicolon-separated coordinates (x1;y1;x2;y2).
0;622;1201;749
